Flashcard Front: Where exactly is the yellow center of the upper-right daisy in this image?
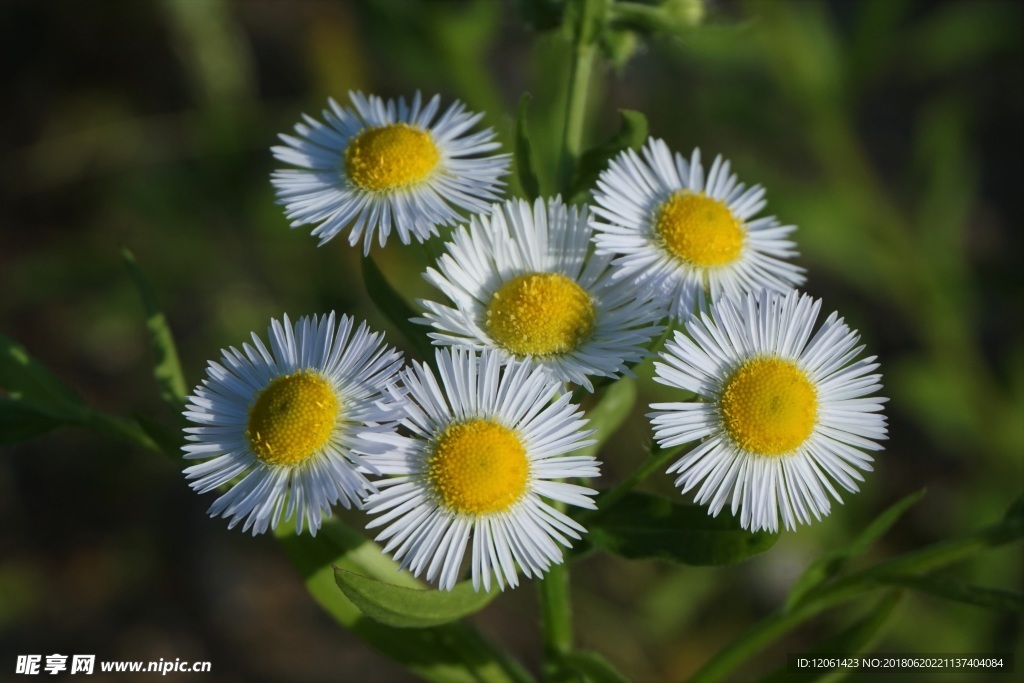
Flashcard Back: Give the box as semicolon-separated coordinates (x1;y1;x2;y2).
654;190;744;266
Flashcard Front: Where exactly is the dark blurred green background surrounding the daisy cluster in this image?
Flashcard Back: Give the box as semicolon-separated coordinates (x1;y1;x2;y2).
0;0;1024;681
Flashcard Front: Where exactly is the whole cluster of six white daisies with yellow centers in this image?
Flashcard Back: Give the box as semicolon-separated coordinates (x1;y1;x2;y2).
184;93;886;590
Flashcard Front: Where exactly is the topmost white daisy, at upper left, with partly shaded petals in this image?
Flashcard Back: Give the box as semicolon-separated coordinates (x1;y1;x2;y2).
271;92;509;254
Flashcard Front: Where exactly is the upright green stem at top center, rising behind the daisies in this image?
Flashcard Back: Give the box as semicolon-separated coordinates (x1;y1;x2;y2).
558;0;607;199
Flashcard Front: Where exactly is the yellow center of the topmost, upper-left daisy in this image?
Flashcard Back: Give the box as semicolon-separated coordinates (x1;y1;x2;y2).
345;123;441;193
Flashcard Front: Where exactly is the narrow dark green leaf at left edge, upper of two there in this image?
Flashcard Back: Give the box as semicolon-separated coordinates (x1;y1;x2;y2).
0;335;87;418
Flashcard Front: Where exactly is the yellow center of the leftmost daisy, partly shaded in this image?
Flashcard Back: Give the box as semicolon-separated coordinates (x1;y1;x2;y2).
246;371;340;466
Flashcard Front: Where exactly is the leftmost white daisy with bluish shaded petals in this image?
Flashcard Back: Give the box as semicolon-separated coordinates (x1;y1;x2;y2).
182;312;402;536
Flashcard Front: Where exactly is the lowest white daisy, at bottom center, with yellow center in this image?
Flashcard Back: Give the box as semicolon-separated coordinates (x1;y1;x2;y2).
366;348;599;590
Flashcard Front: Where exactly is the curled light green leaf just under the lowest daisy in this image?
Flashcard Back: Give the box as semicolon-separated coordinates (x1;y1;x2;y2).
334;567;499;629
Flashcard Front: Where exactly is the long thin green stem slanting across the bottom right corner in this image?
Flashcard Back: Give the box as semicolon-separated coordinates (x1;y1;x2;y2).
690;519;1022;683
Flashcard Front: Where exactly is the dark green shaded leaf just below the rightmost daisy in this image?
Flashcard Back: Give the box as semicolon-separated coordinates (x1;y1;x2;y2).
588;492;778;566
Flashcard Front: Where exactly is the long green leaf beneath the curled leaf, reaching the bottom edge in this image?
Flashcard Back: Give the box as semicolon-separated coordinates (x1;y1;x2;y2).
278;518;532;683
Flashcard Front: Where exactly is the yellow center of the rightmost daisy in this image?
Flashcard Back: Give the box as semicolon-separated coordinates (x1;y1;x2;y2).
721;357;818;456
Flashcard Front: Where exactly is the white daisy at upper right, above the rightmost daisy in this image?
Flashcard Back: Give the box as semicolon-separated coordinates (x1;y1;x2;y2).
591;138;804;321
